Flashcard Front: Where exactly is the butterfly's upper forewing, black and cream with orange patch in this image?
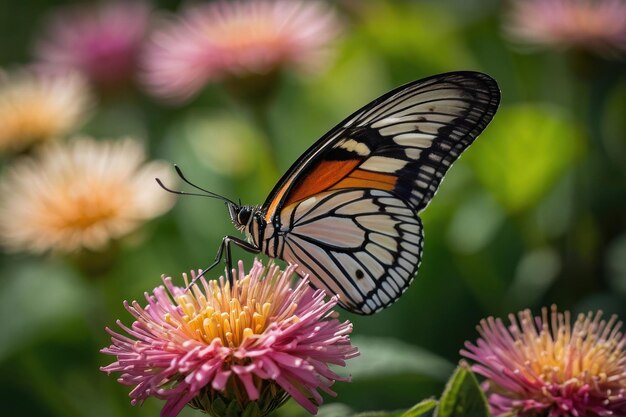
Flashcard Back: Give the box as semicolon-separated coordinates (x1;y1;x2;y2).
263;72;500;223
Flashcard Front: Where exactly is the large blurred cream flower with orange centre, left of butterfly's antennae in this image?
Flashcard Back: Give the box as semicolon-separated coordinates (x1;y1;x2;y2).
0;137;173;253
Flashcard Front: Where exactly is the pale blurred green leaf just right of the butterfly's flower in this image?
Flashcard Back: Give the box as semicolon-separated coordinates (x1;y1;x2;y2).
348;337;453;381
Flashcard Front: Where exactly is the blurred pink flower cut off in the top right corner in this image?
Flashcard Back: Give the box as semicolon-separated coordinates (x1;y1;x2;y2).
505;0;626;54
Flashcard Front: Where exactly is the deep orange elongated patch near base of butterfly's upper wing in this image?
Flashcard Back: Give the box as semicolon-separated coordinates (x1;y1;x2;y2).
280;159;362;206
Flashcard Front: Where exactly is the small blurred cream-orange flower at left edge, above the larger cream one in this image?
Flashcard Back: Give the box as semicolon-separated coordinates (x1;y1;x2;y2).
0;69;93;152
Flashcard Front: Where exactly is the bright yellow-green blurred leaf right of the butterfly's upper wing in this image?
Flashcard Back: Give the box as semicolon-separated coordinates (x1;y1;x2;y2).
468;104;582;212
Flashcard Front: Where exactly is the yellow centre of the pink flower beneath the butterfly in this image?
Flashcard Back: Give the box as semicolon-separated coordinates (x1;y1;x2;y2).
175;276;298;348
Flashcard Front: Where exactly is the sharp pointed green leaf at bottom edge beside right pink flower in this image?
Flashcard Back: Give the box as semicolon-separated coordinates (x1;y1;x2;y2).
435;363;491;417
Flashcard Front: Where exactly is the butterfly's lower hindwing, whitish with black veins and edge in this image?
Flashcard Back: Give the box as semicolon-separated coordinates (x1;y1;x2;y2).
281;189;422;314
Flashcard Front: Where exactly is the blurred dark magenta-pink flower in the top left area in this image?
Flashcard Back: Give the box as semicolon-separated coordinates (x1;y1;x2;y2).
35;0;150;89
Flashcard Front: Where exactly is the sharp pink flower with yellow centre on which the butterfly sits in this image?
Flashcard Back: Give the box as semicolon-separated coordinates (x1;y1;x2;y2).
102;261;358;417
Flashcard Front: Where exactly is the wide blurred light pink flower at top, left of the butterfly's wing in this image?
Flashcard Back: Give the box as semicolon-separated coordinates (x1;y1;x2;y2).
144;0;339;101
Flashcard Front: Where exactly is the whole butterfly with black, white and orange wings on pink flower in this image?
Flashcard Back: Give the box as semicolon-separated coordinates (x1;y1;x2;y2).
159;71;500;315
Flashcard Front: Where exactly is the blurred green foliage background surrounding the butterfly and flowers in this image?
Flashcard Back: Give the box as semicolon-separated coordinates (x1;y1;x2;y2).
0;0;626;417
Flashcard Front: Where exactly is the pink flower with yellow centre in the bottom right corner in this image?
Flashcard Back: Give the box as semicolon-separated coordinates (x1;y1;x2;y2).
461;306;626;417
